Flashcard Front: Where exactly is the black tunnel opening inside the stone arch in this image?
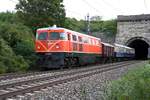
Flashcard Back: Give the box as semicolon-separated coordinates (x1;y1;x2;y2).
128;39;149;60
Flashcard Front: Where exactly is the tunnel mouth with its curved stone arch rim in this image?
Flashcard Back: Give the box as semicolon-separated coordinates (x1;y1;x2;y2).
126;37;150;59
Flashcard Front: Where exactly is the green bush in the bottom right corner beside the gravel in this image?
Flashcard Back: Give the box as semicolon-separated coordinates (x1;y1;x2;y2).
105;64;150;100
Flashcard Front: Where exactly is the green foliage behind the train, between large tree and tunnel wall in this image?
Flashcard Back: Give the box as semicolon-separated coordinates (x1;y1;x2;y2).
65;17;117;37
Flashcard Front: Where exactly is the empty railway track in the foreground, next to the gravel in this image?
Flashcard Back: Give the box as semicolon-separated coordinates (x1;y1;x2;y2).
0;61;139;99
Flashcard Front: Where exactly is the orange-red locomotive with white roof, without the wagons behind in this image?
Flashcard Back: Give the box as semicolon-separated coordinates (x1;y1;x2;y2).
35;27;102;68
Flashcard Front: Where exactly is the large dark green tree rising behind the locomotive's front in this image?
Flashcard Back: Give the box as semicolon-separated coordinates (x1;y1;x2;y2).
16;0;65;30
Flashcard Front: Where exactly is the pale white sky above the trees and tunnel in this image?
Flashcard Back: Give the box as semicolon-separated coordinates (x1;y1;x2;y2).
0;0;150;20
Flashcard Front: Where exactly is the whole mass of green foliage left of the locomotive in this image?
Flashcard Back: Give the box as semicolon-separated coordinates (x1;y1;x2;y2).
0;12;36;73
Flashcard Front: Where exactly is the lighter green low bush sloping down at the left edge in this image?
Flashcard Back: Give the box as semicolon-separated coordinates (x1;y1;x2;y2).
0;37;29;74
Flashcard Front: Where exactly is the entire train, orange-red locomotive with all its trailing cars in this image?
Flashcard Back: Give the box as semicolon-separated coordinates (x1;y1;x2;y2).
35;26;135;68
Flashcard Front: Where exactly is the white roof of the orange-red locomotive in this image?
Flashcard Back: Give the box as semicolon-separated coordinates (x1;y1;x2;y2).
37;25;101;40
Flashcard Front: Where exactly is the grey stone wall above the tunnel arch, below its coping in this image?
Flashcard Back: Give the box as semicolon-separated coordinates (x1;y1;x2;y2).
115;20;150;45
